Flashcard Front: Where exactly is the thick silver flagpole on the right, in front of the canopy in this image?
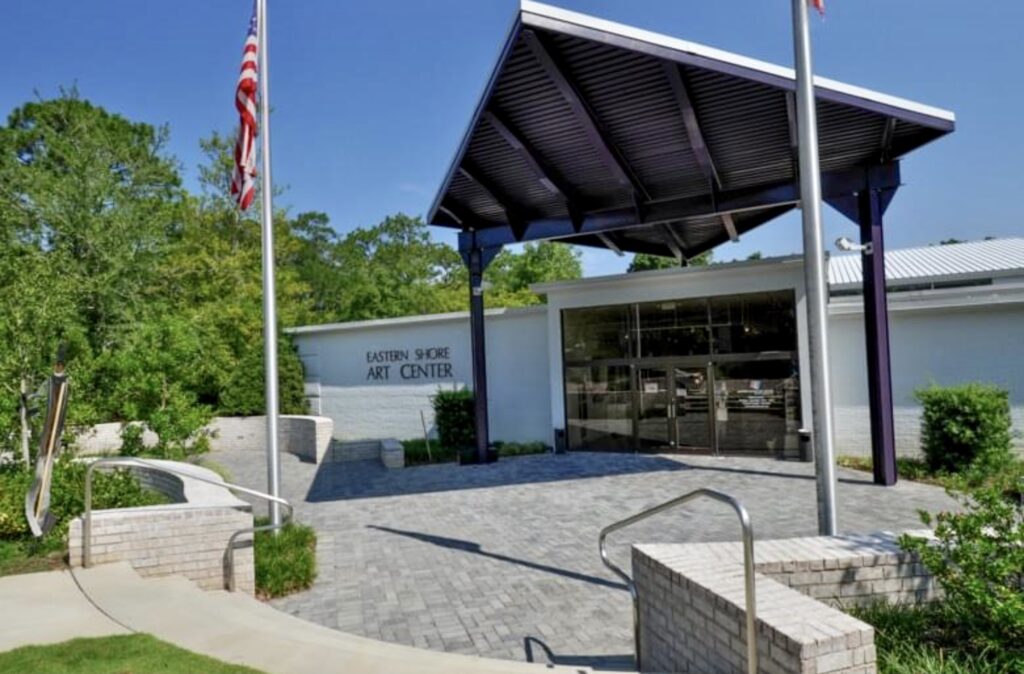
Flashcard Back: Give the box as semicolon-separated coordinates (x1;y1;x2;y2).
793;0;836;536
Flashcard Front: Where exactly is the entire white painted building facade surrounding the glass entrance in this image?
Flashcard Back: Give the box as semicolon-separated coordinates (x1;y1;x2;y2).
286;258;1024;455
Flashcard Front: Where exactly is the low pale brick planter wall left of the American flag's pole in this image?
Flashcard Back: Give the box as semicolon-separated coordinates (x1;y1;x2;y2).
68;460;255;594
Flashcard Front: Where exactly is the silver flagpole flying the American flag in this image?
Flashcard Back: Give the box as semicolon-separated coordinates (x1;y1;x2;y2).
257;0;281;534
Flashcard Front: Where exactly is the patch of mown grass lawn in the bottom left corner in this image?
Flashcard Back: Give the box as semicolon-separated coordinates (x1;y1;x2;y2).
0;634;268;674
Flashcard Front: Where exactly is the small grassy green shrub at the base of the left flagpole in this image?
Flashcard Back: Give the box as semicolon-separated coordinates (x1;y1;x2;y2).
254;517;316;598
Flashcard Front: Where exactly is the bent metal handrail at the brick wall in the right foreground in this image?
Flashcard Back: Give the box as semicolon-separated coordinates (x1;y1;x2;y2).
597;489;758;674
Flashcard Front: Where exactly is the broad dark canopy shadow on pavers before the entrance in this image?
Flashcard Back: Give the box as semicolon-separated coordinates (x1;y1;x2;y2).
306;452;690;503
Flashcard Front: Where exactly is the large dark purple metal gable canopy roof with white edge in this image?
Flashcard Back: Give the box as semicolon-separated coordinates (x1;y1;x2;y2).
428;1;955;262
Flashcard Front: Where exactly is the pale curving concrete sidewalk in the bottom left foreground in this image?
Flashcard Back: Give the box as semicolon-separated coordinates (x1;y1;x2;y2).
0;563;589;674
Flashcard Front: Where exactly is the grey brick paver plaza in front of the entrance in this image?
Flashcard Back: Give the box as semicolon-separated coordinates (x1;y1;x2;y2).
211;452;952;669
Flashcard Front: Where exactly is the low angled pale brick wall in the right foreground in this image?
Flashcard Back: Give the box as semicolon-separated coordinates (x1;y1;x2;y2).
633;536;937;674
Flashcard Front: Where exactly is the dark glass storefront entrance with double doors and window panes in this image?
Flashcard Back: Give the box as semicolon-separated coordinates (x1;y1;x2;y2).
562;291;800;453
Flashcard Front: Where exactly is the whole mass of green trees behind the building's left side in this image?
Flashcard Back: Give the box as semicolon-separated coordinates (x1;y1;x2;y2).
0;90;582;455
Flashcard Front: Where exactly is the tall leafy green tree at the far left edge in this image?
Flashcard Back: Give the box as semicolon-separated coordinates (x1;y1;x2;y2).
0;90;183;446
